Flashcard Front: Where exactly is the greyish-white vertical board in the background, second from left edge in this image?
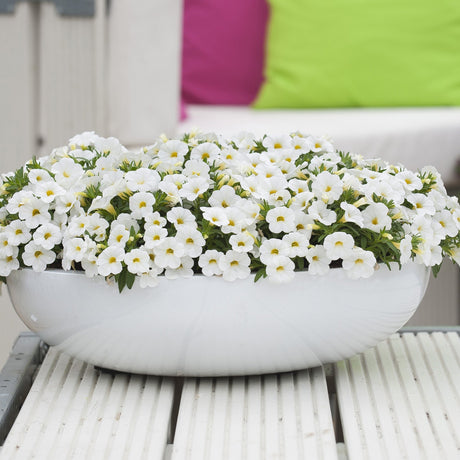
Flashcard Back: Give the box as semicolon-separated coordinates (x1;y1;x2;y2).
39;3;96;153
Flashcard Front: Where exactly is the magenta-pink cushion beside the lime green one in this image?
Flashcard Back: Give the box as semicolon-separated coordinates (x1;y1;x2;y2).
182;0;268;105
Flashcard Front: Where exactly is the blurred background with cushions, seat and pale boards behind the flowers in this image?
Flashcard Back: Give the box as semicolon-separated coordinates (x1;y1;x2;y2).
0;0;460;366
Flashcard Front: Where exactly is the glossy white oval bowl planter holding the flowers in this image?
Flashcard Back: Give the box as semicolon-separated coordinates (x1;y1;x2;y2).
8;263;429;376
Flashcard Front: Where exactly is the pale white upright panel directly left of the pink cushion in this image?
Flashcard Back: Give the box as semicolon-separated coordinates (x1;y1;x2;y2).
107;0;182;145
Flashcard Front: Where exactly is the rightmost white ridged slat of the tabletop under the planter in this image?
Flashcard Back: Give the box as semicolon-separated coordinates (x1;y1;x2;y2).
335;333;460;460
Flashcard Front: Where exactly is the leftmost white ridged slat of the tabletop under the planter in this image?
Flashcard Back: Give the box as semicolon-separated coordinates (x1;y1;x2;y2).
0;349;174;460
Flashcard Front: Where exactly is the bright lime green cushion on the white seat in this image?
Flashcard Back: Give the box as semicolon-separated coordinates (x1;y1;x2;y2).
254;0;460;108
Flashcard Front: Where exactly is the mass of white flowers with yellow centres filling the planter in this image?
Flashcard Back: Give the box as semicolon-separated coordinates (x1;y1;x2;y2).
0;132;460;290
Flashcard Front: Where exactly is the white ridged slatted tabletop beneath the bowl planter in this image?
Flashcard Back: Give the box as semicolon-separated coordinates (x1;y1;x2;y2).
0;328;460;460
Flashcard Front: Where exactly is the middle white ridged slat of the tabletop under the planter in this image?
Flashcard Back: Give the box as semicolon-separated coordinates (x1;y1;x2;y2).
172;368;337;460
